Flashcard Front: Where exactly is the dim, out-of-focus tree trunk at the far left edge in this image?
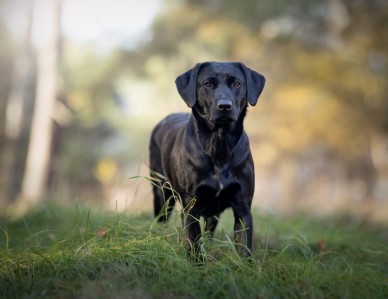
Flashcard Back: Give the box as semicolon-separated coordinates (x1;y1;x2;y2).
1;0;35;201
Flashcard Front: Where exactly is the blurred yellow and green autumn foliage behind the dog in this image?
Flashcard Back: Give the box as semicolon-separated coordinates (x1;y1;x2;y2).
0;0;388;220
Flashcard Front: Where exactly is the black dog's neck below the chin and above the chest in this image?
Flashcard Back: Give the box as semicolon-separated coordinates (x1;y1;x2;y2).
191;107;246;165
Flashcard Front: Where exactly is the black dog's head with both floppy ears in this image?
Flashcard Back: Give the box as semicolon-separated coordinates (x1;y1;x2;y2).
175;62;265;125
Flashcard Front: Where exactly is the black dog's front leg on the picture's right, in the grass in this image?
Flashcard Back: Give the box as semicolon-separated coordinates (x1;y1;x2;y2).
233;203;253;257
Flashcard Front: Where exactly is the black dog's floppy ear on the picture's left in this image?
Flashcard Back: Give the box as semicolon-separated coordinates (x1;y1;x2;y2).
175;63;201;108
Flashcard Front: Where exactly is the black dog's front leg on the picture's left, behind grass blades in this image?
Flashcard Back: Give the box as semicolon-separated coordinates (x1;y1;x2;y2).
183;212;203;263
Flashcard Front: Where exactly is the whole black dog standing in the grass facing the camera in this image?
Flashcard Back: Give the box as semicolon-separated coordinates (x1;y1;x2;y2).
150;62;265;259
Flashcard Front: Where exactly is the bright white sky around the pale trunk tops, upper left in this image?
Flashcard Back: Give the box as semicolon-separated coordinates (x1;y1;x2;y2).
1;0;161;50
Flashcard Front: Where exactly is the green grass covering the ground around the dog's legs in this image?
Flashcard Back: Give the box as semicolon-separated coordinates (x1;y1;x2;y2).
0;204;388;298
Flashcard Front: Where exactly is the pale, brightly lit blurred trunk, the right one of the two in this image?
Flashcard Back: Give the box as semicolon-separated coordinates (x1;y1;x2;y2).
20;0;62;203
